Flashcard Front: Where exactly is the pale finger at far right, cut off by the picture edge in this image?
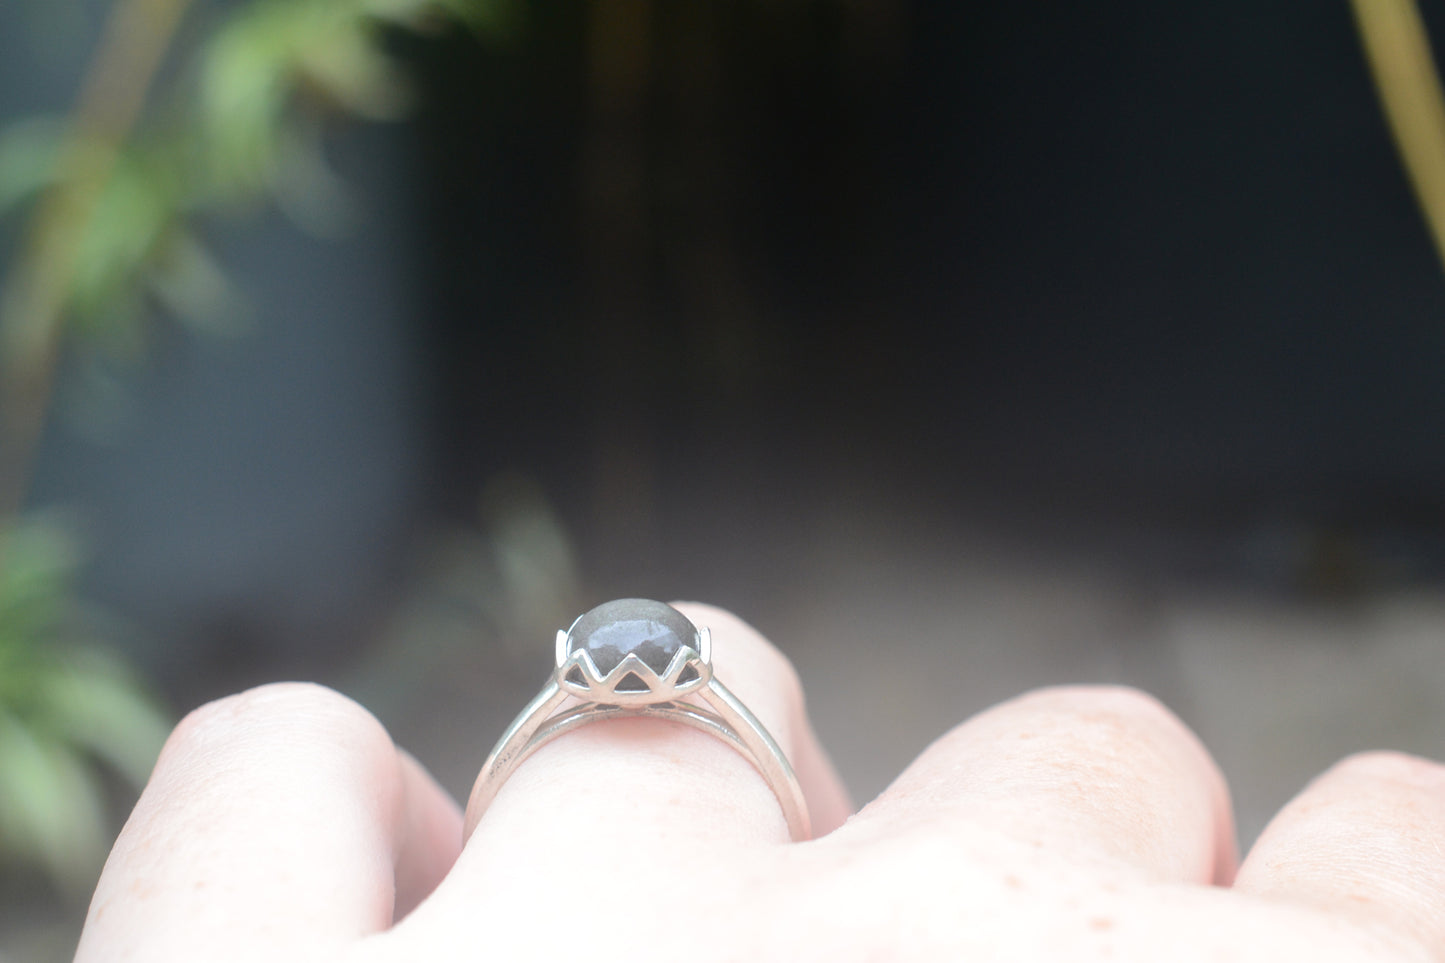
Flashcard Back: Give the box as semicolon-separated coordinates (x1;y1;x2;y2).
1234;752;1445;953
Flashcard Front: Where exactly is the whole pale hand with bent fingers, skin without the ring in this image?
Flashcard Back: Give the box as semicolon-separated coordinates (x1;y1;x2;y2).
77;603;1445;963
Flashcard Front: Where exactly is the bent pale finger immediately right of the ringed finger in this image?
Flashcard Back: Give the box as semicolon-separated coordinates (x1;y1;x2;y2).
838;687;1234;882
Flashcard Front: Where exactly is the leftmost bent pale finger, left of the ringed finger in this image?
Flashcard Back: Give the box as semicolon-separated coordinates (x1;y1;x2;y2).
75;684;461;962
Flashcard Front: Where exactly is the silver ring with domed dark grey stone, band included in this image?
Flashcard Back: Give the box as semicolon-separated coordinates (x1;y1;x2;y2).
467;599;812;840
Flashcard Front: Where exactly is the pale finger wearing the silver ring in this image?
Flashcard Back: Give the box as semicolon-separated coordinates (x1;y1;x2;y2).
462;603;848;861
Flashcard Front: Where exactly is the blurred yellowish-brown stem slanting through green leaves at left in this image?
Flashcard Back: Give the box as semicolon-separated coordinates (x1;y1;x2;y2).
0;0;191;517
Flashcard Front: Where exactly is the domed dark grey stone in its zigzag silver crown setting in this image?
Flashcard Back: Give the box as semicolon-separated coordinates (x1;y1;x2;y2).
556;599;711;706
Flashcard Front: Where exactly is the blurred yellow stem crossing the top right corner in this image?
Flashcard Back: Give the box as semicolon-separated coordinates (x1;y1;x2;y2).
1353;0;1445;270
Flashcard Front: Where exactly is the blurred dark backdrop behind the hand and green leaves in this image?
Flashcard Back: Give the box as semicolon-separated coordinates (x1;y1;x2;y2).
8;0;1445;953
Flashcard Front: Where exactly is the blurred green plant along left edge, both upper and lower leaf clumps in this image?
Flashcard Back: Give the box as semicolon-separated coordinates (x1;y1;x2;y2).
0;0;503;892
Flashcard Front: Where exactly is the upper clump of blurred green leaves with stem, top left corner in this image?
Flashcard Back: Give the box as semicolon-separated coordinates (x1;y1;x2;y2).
0;0;506;515
